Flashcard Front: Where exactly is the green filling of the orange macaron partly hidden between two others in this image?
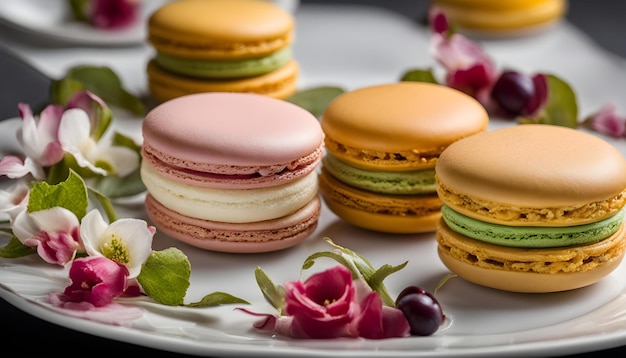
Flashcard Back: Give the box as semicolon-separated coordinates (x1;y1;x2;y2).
323;154;437;195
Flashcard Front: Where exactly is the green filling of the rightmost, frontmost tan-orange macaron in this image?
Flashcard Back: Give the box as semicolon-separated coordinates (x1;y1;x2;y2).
441;205;624;248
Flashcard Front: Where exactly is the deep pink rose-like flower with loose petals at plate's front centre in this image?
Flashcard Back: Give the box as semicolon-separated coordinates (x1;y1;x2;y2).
241;265;409;339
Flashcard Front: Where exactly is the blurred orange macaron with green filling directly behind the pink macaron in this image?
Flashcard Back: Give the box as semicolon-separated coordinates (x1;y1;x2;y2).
147;0;299;102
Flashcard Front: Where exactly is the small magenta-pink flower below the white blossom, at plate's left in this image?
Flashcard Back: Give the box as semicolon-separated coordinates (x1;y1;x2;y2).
55;256;134;307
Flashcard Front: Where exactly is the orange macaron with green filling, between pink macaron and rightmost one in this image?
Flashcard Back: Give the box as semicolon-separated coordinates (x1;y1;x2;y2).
319;82;489;234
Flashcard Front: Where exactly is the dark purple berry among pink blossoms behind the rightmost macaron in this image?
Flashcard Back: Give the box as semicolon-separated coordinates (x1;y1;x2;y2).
491;71;535;116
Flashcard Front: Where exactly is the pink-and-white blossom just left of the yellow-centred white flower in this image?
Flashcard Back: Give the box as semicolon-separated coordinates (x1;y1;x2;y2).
13;206;83;266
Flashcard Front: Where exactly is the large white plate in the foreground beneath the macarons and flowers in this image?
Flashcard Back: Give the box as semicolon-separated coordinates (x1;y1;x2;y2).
0;114;626;357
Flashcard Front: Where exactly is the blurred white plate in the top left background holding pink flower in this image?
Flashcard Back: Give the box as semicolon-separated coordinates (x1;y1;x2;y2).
0;0;167;46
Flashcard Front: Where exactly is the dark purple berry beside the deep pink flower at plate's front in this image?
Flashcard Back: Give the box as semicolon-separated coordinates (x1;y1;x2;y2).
396;286;445;336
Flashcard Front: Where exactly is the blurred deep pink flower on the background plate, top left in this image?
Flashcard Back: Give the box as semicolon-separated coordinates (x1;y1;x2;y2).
91;0;140;29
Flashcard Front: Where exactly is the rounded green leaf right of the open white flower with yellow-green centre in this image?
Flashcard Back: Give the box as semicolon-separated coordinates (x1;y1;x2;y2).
137;247;191;306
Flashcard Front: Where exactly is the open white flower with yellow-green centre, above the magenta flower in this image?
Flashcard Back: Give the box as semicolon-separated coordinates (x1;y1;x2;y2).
80;209;155;278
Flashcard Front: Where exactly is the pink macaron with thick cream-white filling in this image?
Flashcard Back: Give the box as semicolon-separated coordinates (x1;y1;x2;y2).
141;92;324;253
